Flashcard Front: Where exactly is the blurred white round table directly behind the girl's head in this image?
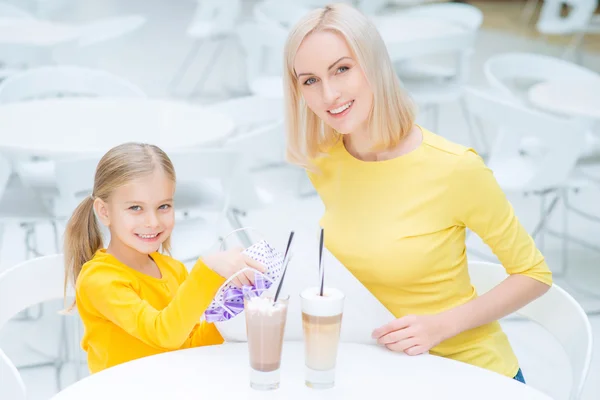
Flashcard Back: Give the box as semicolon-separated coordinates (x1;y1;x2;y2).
0;97;234;158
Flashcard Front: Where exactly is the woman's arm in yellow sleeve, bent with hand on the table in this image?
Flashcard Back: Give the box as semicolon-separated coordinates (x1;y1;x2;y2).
373;151;552;354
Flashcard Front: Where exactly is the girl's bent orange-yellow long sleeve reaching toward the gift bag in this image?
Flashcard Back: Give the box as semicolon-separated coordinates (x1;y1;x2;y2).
79;260;224;350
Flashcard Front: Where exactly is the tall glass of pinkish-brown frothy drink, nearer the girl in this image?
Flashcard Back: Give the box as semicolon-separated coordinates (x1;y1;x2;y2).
244;296;289;390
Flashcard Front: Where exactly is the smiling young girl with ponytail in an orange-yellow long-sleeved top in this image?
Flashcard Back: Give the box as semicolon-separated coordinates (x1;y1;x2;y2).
64;143;264;373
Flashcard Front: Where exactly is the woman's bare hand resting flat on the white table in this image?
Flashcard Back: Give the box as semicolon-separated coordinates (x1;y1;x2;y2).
372;314;451;356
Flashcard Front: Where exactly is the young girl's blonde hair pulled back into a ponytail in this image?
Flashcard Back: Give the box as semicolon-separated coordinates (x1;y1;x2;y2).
64;143;175;311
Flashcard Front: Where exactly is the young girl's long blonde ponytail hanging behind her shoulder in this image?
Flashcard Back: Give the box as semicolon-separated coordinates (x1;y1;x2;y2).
64;196;103;312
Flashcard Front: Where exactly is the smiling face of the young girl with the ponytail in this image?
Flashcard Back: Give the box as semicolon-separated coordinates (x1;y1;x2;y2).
97;168;175;254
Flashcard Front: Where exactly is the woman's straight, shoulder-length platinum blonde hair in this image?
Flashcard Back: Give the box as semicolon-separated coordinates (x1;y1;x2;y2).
283;4;415;169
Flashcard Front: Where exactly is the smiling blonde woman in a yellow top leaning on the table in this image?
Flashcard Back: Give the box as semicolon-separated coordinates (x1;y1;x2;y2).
284;4;552;382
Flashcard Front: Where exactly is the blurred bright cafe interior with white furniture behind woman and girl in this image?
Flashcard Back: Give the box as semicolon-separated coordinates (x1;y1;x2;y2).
0;0;600;400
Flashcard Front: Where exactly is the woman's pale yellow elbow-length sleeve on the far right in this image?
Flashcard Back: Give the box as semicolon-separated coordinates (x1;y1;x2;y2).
448;150;552;285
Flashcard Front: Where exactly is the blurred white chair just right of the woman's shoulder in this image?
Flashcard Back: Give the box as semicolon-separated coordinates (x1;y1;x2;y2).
464;88;589;255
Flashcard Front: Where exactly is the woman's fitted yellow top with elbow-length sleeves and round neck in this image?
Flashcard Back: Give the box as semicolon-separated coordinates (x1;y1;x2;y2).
309;129;552;377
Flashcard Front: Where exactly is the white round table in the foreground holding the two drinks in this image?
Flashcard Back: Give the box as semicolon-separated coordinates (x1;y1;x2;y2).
53;342;550;400
